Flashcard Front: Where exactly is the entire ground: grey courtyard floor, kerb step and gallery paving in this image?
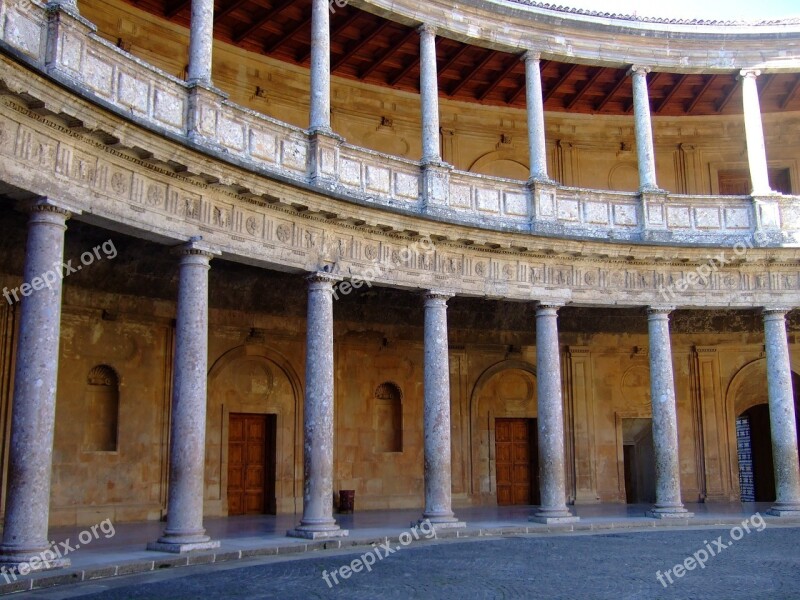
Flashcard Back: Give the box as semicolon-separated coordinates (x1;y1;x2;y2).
0;504;800;600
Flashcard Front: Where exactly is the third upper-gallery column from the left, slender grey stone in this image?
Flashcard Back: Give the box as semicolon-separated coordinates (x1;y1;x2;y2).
417;25;442;164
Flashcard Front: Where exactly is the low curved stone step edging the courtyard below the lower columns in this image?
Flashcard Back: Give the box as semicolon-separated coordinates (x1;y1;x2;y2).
0;515;800;595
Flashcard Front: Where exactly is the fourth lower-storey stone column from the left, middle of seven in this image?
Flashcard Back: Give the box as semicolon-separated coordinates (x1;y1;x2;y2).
422;291;466;527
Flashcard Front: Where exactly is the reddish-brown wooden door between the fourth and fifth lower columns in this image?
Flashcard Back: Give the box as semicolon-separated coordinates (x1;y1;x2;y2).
495;419;539;506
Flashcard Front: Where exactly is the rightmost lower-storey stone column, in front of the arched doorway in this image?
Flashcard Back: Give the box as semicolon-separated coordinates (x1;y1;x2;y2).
764;308;800;517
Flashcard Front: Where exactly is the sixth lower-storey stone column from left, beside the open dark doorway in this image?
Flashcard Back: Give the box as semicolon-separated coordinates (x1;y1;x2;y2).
647;306;694;519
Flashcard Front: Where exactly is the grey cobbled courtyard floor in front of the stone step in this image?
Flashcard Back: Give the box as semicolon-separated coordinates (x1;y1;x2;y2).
17;525;800;600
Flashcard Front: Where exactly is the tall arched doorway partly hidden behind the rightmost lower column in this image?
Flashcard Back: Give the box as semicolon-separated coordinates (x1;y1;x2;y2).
731;359;800;502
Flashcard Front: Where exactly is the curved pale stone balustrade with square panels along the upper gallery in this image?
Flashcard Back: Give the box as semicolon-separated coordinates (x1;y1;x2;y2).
0;0;800;246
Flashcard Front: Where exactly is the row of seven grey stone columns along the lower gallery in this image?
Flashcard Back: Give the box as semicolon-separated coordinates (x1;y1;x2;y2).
0;198;800;563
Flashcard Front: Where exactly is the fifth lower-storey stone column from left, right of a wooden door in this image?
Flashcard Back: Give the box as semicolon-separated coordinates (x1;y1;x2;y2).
530;304;579;523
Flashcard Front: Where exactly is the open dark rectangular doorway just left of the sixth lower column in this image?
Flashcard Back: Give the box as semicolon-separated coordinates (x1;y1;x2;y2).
622;419;656;504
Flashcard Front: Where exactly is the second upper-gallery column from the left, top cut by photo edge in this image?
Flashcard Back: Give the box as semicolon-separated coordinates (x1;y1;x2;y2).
309;0;332;133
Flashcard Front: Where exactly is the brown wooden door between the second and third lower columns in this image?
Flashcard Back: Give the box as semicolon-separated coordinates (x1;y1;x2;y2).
228;413;277;515
